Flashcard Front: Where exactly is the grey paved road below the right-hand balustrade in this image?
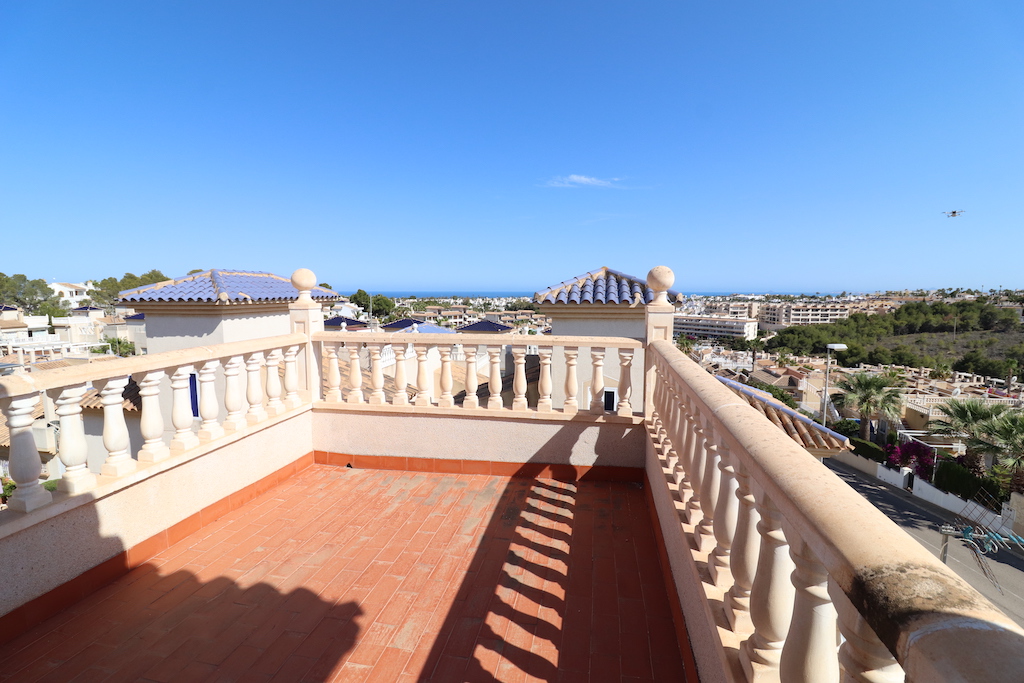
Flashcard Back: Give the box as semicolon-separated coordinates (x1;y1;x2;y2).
824;458;1024;626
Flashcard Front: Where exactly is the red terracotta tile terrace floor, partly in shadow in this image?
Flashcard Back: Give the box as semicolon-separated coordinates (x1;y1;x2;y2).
0;465;684;683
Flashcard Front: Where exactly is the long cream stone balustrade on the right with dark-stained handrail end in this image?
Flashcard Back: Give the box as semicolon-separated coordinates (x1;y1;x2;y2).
647;341;1024;683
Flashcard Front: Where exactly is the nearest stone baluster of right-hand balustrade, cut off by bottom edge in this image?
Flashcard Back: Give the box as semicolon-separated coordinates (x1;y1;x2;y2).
828;578;906;683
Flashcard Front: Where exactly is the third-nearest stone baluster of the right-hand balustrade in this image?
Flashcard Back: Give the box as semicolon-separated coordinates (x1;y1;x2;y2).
739;489;798;683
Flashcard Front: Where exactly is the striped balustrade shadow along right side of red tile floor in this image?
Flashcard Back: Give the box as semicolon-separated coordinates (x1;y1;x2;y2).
411;425;683;683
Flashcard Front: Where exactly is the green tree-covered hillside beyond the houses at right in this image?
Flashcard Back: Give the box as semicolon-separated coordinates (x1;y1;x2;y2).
767;297;1024;377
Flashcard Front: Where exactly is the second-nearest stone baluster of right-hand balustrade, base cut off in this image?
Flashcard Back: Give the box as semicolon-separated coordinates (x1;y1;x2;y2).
779;533;839;683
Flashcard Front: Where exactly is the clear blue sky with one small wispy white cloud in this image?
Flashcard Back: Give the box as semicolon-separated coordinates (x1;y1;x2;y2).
0;0;1024;292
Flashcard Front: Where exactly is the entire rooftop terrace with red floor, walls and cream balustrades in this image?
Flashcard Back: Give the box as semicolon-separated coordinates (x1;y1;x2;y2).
0;270;1024;683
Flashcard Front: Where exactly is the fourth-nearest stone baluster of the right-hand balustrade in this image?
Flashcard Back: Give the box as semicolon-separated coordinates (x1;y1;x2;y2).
724;448;761;633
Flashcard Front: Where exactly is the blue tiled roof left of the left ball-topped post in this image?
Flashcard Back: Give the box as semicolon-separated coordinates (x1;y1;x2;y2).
119;269;340;302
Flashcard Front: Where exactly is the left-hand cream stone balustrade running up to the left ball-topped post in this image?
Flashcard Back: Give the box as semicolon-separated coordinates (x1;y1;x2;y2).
0;334;309;512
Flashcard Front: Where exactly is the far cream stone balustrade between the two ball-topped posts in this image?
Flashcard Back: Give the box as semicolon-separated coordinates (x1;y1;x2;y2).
313;332;643;417
